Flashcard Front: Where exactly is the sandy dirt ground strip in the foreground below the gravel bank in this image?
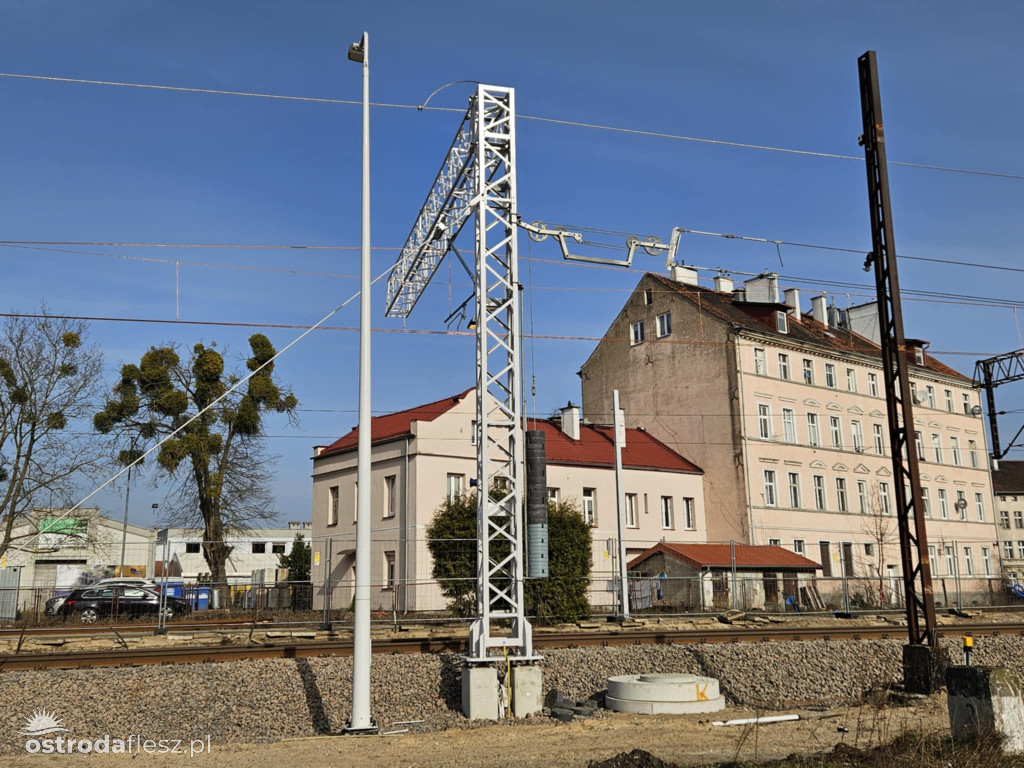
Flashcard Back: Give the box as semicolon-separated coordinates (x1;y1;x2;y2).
4;694;949;768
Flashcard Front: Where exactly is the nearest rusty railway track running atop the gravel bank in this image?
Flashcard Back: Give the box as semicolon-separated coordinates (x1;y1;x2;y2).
0;622;1024;672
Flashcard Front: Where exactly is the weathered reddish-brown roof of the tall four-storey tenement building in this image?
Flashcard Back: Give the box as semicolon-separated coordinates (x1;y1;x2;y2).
641;272;970;381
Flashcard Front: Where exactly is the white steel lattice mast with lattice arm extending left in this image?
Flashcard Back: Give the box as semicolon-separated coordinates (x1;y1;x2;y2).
387;85;532;662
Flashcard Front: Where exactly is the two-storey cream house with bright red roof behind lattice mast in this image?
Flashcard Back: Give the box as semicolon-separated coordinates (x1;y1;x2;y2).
312;389;707;613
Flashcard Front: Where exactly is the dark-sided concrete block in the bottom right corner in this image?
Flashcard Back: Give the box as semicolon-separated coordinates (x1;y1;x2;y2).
946;667;1024;755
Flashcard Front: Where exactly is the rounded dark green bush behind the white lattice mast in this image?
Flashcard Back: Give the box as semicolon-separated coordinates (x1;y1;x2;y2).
426;493;591;623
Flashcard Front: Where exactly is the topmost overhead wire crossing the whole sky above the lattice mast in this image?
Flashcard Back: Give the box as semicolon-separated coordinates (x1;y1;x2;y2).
0;72;1024;181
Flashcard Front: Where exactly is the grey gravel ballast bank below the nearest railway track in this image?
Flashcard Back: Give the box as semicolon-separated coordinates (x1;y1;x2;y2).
6;636;1024;754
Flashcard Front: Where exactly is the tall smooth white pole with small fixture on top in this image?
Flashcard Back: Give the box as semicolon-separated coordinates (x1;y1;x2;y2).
347;32;375;731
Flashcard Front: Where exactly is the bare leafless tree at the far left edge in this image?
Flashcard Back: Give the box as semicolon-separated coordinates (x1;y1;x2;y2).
0;309;106;557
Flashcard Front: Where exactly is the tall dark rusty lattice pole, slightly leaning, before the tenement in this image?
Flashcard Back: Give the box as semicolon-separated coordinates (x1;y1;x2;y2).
857;51;937;693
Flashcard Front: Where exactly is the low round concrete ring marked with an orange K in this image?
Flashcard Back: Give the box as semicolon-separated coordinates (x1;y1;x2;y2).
605;675;725;715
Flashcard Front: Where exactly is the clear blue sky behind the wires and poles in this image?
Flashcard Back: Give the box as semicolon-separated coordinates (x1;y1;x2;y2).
0;0;1024;524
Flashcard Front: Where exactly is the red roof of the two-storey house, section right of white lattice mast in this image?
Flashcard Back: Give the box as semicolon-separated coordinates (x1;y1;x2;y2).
526;419;703;474
